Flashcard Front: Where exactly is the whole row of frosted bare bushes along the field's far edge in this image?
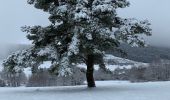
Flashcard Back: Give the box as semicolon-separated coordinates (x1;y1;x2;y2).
0;60;170;87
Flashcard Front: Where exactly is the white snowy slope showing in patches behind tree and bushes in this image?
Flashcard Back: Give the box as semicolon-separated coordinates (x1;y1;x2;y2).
0;54;148;76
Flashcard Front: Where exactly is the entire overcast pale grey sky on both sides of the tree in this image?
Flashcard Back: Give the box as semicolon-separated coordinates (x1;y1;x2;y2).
0;0;170;47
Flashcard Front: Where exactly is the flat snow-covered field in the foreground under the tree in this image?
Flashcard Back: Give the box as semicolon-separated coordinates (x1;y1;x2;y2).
0;81;170;100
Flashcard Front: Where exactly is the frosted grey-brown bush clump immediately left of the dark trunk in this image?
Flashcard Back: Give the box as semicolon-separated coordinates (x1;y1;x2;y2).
27;67;85;87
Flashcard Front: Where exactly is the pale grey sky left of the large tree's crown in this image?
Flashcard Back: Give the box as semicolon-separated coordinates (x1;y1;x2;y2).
0;0;48;44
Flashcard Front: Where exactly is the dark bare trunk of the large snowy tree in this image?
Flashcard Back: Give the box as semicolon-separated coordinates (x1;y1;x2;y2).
86;55;96;88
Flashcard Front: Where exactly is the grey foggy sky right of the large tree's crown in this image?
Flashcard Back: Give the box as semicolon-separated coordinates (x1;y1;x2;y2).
119;0;170;47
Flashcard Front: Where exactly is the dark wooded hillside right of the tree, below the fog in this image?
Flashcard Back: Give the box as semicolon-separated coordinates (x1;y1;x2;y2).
109;44;170;63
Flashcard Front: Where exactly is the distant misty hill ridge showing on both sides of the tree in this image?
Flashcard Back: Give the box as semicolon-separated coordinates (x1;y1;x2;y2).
0;44;170;63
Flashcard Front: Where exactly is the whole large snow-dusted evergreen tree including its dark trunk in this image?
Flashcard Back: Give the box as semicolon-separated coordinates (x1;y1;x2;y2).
4;0;151;87
